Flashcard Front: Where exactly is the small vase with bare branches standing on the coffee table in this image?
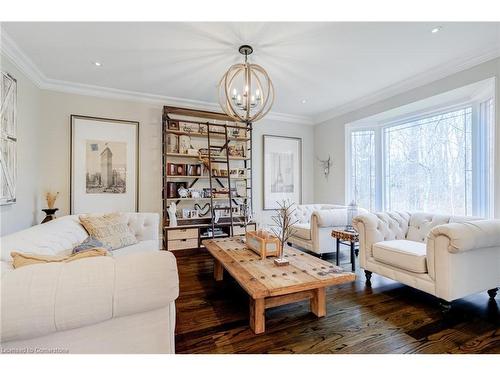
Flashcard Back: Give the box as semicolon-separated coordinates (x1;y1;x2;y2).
270;200;298;266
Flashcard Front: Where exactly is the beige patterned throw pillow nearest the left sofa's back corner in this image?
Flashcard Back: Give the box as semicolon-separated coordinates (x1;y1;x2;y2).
79;213;138;250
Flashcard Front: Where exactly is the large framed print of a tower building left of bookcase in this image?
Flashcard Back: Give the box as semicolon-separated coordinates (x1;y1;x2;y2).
70;115;139;214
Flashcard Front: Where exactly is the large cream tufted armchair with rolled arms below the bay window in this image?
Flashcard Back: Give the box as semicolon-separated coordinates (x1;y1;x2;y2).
353;212;500;309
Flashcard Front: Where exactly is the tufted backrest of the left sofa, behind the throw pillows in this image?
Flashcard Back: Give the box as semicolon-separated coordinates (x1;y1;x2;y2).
0;212;160;262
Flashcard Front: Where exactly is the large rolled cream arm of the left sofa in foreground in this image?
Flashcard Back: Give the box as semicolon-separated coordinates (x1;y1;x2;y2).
0;251;179;342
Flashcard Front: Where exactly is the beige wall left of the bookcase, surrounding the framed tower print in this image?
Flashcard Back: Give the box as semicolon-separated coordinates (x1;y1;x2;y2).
40;90;162;219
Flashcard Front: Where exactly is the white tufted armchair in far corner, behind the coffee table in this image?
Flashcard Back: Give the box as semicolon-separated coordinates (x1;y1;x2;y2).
288;204;367;255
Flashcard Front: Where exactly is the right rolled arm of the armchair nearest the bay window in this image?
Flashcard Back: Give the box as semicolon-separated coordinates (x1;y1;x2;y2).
429;220;500;253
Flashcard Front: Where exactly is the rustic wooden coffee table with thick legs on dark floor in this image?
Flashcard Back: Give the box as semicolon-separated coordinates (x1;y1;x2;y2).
203;237;355;333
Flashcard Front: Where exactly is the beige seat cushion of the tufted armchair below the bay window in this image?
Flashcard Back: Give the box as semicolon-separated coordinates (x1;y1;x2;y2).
372;240;427;273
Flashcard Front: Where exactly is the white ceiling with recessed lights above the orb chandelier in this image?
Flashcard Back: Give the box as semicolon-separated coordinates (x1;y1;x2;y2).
2;22;500;119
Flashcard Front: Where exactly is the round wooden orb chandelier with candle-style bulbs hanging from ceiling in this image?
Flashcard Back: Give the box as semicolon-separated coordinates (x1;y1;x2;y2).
219;45;274;123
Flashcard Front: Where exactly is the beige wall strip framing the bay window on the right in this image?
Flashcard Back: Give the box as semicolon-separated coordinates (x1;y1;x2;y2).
314;58;500;218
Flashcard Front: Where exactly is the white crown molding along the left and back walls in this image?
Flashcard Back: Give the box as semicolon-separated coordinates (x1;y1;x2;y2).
0;28;314;126
